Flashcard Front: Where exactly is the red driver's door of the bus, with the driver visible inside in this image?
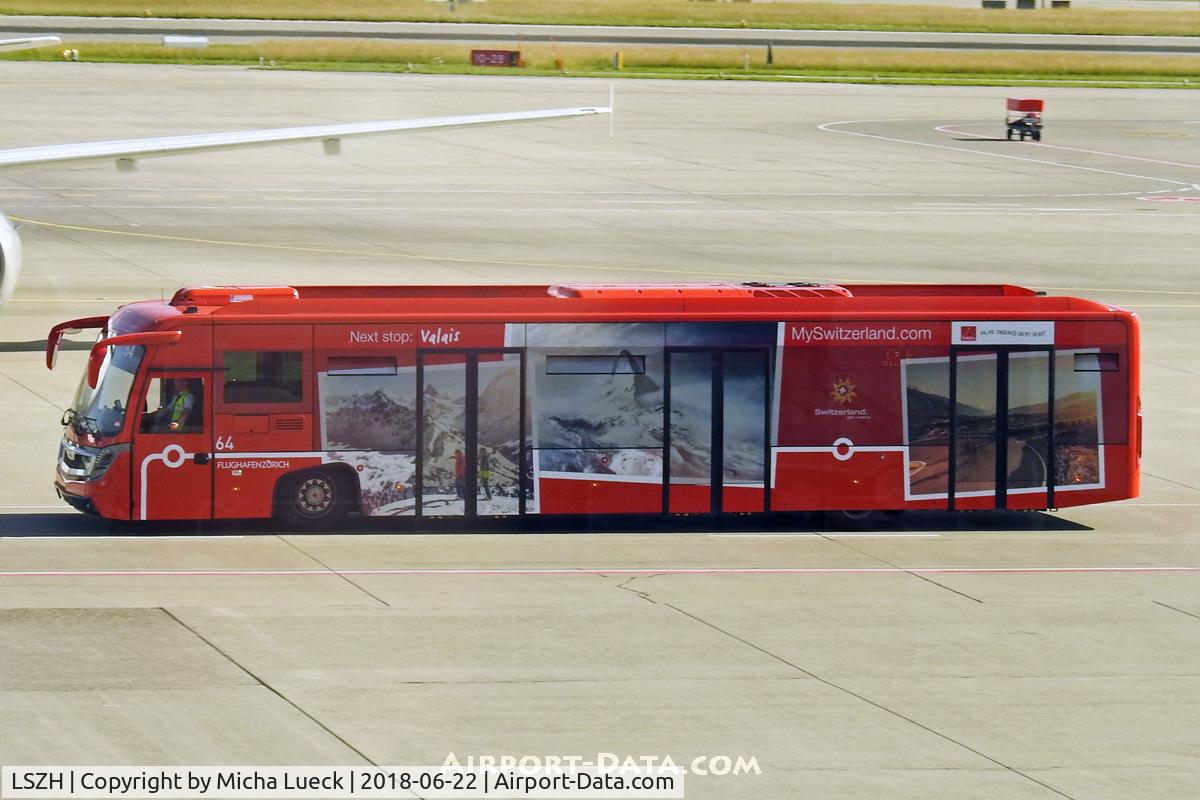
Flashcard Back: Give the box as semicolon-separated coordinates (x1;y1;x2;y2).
133;368;212;519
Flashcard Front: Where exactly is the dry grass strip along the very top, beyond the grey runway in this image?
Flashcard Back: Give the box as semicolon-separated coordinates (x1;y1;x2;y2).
0;0;1200;36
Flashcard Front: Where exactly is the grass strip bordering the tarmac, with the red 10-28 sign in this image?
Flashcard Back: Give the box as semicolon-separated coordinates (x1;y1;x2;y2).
9;40;1200;88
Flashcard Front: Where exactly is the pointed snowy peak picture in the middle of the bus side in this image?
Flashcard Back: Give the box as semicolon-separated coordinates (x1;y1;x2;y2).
526;323;776;483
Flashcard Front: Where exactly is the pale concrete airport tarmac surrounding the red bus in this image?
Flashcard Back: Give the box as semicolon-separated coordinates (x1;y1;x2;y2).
0;62;1200;800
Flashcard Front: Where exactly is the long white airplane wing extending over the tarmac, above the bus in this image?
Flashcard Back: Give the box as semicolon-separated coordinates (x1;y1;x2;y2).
0;108;612;169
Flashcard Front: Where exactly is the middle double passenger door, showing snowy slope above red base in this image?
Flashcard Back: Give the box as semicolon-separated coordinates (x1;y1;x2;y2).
662;348;772;513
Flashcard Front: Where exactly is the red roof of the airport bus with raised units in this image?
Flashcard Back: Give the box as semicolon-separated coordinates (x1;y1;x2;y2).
103;283;1127;331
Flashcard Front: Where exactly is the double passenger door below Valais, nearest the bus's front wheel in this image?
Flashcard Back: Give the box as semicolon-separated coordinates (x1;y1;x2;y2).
416;348;532;518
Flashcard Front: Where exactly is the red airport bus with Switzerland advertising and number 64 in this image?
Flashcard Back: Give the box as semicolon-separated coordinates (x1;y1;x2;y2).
47;284;1141;528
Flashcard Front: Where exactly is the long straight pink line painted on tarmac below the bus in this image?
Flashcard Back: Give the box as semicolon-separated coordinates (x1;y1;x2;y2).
0;565;1200;578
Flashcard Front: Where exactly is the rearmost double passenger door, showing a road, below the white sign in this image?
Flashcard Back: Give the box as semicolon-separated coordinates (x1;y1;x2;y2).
947;345;1055;510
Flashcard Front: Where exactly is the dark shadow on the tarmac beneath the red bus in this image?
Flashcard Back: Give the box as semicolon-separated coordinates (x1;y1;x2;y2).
0;511;1093;539
